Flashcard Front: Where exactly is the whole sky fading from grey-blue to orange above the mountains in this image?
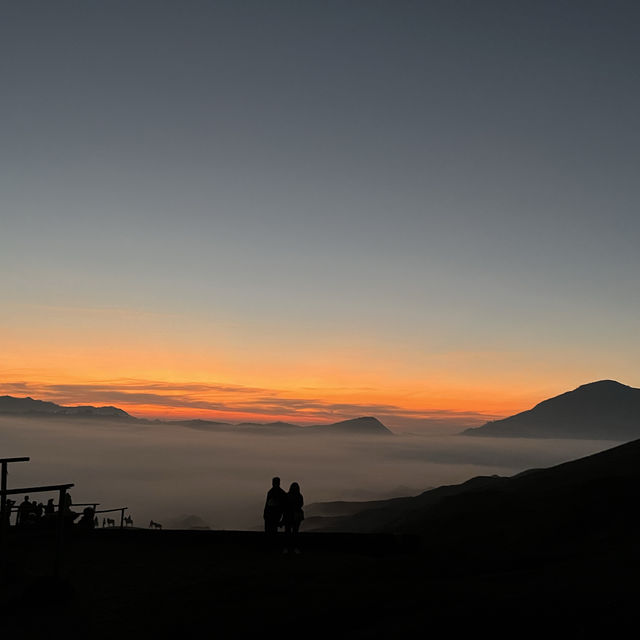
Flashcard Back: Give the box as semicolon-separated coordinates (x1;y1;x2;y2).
0;0;640;429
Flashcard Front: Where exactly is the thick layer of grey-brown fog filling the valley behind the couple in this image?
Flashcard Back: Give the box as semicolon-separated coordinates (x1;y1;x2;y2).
0;416;614;529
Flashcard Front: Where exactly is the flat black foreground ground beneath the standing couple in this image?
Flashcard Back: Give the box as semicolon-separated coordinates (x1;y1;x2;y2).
1;530;640;638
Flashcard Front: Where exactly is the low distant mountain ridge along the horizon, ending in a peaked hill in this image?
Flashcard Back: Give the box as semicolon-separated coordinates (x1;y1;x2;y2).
0;396;393;435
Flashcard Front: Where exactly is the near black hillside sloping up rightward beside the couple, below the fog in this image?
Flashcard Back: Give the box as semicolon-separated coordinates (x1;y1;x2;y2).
305;440;640;545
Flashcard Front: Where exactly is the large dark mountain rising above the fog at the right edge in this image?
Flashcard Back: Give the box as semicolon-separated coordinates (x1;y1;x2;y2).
463;380;640;441
